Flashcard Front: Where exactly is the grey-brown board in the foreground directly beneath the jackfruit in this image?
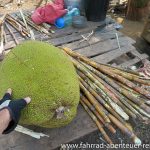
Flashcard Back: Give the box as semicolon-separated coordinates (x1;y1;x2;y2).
0;105;97;150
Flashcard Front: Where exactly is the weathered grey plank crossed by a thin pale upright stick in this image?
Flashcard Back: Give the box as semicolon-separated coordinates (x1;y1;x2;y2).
76;37;134;57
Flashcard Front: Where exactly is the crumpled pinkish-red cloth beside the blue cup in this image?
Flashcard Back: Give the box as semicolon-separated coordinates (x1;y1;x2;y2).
31;0;67;25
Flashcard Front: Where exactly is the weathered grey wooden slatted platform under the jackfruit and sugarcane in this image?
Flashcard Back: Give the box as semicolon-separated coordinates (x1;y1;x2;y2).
0;14;148;150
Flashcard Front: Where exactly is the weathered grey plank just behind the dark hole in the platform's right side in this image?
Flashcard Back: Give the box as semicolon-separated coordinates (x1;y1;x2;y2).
92;46;135;63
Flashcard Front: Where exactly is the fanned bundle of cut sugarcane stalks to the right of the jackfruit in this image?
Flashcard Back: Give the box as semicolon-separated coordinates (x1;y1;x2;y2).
62;48;150;144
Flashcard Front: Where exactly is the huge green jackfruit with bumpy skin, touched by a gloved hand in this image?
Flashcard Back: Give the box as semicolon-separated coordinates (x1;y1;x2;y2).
0;41;80;128
